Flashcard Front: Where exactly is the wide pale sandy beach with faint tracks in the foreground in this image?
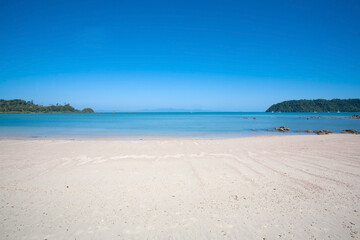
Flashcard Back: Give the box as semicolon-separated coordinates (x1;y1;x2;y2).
0;135;360;240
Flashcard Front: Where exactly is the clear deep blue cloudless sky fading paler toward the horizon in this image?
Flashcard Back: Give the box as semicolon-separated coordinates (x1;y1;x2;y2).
0;0;360;111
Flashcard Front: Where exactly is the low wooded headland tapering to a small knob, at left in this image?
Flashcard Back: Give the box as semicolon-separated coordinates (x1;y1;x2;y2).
0;99;94;113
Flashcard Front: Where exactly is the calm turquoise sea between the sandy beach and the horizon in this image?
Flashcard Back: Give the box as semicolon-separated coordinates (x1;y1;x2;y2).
0;112;360;138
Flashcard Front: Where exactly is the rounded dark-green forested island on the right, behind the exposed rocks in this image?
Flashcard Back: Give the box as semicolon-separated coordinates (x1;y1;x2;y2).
266;99;360;112
